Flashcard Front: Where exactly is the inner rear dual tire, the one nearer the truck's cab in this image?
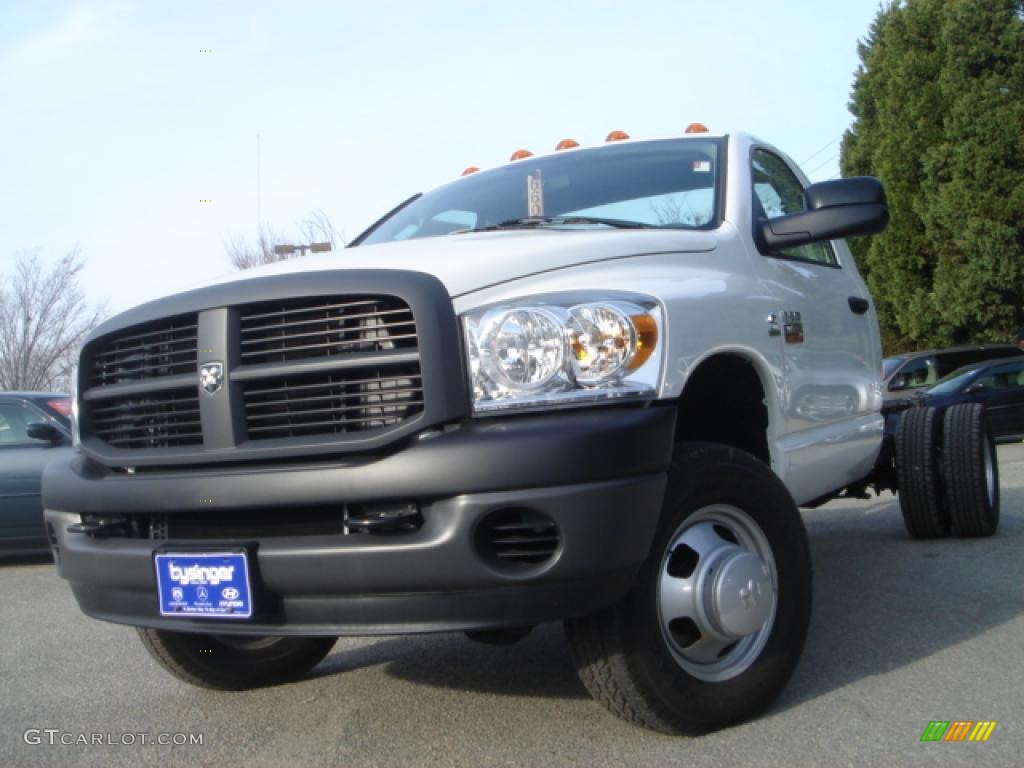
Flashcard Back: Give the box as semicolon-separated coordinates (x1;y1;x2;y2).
895;408;949;539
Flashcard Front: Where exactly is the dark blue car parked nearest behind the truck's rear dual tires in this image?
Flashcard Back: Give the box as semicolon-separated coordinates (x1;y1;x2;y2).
885;356;1024;442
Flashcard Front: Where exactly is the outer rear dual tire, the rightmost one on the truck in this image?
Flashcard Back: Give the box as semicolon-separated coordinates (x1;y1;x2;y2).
942;402;999;538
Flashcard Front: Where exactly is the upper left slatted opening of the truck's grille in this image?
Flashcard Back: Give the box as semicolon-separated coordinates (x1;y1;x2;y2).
89;314;198;386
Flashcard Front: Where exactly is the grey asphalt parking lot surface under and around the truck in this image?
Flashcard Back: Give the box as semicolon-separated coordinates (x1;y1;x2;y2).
0;444;1024;767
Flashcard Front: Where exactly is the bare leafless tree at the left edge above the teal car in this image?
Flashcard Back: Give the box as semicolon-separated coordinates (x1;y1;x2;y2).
0;249;105;391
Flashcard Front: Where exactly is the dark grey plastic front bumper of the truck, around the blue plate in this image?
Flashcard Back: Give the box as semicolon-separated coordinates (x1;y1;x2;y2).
43;408;674;635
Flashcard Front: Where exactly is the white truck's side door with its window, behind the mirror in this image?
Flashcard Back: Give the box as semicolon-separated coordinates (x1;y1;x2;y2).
751;147;882;501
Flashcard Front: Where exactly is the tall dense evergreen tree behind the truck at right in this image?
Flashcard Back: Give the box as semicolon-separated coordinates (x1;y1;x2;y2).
841;0;1024;353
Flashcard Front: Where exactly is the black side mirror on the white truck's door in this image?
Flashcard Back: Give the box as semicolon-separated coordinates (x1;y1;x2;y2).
754;176;889;253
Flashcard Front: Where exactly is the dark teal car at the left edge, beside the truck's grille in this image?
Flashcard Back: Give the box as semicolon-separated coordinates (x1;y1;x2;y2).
0;392;72;555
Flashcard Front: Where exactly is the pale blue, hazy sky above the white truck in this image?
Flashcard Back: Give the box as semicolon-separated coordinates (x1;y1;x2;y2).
0;0;879;312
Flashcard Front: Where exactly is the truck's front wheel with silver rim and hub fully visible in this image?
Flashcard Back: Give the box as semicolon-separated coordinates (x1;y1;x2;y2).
566;443;811;734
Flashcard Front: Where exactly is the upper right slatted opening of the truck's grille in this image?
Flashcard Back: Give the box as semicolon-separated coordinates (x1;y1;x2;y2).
240;296;417;365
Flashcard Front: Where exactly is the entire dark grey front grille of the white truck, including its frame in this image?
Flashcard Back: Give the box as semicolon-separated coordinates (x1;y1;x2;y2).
78;269;456;466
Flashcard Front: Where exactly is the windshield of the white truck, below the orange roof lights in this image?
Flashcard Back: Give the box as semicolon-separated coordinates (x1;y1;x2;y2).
357;138;722;245
